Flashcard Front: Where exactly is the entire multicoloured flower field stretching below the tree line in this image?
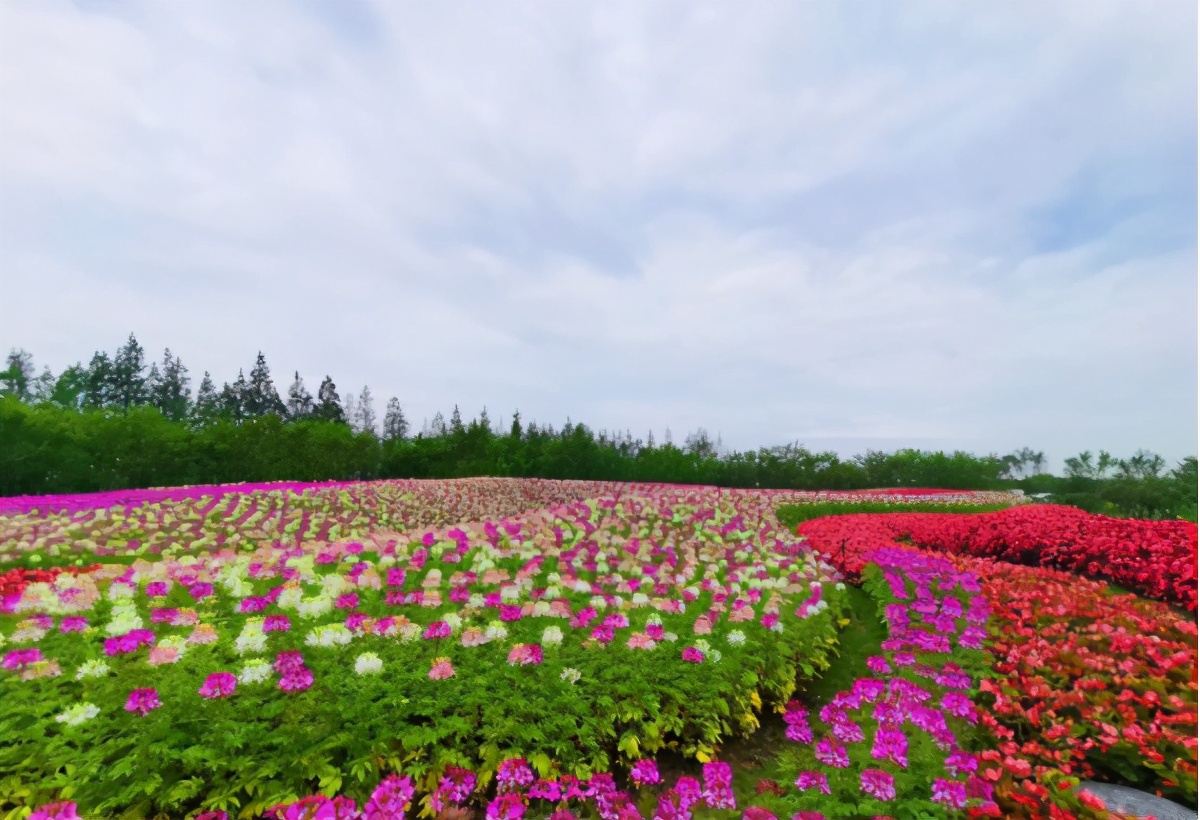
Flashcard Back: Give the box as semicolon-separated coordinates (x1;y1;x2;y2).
0;479;1196;820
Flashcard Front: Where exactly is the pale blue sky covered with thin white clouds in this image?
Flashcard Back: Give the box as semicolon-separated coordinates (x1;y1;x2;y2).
0;0;1198;472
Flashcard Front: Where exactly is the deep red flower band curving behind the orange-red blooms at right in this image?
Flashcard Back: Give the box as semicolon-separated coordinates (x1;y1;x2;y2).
797;504;1196;612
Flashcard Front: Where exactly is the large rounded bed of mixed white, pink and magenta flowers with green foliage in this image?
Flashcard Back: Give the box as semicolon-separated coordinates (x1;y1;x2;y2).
0;487;844;815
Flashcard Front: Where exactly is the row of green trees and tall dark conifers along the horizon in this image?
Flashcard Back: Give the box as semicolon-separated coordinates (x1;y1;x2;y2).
0;334;1196;520
